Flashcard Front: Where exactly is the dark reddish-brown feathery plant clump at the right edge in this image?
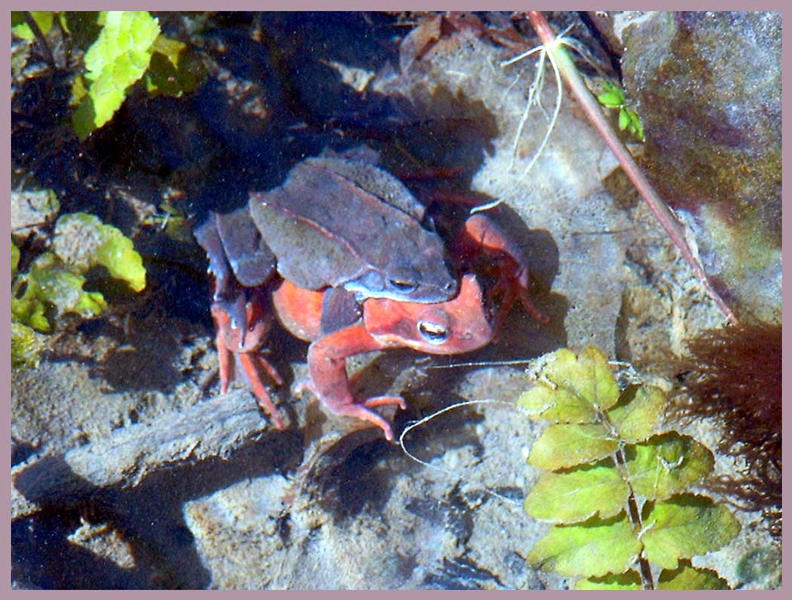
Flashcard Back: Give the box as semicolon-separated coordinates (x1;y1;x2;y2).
668;321;782;539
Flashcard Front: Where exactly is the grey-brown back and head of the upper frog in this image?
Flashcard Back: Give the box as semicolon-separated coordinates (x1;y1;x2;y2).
249;156;456;302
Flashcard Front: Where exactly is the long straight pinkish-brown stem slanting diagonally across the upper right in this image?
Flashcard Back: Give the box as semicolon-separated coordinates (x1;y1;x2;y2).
528;11;737;325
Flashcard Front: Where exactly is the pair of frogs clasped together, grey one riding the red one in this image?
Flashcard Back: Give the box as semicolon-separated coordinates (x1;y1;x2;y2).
196;150;547;439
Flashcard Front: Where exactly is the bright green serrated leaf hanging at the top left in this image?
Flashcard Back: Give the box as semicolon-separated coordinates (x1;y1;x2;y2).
72;11;160;139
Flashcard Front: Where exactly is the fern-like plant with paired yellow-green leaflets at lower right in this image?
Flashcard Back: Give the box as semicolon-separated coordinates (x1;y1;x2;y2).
517;347;740;589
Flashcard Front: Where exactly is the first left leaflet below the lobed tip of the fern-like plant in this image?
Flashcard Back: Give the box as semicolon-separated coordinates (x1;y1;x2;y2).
528;423;619;470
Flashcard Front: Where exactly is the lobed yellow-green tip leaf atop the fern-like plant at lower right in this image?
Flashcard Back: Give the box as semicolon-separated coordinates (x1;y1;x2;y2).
517;347;619;423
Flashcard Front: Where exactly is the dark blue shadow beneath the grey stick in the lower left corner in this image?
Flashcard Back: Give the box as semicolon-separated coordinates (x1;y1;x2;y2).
11;432;302;589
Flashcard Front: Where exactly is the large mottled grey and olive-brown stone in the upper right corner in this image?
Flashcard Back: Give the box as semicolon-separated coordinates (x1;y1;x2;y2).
616;11;781;322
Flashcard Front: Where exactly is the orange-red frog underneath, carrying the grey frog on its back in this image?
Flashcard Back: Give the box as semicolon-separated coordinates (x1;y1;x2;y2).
212;215;547;440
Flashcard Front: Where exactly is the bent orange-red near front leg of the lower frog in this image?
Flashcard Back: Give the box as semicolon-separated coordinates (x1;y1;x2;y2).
308;322;406;440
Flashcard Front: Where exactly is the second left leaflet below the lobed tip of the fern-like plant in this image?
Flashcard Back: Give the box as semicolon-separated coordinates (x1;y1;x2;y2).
524;461;630;523
